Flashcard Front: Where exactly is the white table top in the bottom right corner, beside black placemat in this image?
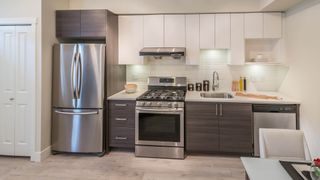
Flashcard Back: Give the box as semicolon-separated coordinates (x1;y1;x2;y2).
241;157;292;180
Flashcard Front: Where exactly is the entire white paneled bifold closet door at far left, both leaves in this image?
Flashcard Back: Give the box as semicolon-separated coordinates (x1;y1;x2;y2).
0;26;35;156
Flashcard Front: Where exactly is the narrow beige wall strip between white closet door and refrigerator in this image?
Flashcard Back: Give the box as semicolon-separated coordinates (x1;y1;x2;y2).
41;0;69;151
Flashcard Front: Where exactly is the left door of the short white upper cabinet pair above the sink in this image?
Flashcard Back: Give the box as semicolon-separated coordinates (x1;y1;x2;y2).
200;14;215;49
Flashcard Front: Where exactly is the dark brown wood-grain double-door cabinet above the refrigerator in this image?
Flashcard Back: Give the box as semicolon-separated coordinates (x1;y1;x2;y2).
56;10;107;39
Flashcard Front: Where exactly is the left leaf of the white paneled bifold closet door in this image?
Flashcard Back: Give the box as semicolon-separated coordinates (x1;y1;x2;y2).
0;26;16;156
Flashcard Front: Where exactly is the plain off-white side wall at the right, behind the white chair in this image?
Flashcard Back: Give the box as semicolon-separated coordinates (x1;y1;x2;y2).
280;0;320;157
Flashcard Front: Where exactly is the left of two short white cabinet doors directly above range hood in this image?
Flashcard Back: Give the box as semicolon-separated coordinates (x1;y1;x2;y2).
143;15;164;47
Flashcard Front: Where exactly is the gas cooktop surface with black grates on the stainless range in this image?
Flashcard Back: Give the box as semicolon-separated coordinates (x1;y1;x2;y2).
137;89;186;101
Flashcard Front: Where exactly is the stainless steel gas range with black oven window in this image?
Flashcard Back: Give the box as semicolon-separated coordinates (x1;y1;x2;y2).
135;77;187;159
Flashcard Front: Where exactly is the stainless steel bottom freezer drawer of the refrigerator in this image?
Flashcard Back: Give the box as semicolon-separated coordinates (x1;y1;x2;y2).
52;109;104;153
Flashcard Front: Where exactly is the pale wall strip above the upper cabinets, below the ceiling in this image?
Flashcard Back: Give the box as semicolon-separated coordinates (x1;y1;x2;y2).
70;0;260;14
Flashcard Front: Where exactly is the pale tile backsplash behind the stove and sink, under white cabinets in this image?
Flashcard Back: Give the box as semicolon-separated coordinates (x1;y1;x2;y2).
127;50;288;91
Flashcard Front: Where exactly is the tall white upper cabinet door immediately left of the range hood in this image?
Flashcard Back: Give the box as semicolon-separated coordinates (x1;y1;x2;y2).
119;16;143;64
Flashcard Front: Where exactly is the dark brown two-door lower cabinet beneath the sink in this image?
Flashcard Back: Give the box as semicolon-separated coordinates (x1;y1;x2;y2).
186;102;253;154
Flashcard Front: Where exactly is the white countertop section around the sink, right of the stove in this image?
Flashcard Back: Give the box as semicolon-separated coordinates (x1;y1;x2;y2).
185;91;300;104
